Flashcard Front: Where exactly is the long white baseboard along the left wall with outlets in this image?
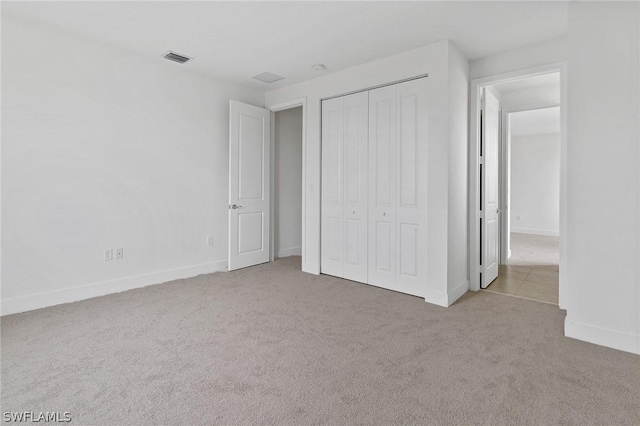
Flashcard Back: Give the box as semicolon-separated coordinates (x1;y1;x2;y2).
1;260;227;315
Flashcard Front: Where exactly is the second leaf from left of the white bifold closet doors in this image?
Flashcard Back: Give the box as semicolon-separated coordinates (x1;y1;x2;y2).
343;92;369;283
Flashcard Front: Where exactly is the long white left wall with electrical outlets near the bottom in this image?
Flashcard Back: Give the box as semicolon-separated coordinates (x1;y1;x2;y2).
2;12;264;314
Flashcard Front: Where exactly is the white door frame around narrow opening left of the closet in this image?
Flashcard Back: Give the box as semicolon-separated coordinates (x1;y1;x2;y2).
265;96;307;265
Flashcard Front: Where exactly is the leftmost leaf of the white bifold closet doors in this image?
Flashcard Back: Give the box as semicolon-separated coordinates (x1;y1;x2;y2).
320;98;344;277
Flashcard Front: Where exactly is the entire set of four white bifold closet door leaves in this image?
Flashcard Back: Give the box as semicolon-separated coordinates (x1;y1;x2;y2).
321;79;427;296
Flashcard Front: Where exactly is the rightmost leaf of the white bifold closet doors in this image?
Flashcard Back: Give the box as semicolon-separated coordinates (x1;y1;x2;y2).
396;79;428;296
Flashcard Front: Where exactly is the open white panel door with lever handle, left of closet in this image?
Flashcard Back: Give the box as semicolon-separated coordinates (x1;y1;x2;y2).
228;100;271;271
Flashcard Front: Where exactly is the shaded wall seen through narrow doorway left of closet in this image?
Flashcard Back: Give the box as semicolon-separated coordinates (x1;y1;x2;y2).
274;107;302;257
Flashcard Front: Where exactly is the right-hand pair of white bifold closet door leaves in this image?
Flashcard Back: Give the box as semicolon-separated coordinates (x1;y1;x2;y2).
368;78;427;296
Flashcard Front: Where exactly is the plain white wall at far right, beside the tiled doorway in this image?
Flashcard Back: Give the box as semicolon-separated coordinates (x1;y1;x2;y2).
565;2;640;354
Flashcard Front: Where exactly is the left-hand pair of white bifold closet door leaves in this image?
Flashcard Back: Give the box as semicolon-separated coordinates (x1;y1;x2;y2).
320;92;369;282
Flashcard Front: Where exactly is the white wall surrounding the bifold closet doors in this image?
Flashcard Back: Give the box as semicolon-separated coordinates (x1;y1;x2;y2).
266;41;468;305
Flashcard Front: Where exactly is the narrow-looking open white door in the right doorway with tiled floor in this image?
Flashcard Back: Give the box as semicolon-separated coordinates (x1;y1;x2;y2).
480;88;500;288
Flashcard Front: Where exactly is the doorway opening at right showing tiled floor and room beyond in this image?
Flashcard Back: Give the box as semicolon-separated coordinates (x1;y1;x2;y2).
486;103;560;304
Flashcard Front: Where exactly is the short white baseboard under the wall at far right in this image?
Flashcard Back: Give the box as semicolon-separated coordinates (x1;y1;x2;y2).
564;317;640;355
